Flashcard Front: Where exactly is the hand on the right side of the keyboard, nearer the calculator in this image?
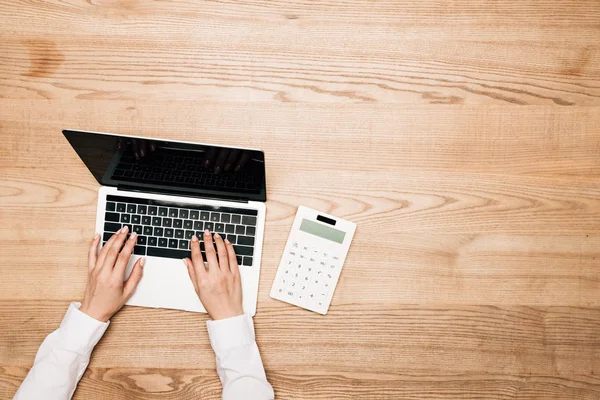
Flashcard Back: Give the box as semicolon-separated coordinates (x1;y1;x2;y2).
183;230;244;320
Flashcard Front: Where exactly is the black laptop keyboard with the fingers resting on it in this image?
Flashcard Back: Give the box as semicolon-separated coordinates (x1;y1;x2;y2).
102;195;258;266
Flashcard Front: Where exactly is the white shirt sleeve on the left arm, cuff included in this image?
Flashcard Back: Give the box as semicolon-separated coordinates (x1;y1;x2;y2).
14;303;109;400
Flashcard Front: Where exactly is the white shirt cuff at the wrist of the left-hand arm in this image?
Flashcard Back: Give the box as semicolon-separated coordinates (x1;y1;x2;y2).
60;303;110;353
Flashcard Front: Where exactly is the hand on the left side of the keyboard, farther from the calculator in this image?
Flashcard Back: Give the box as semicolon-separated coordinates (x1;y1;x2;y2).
79;227;146;322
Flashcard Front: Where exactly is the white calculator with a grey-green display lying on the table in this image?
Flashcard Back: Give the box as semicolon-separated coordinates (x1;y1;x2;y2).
271;206;356;315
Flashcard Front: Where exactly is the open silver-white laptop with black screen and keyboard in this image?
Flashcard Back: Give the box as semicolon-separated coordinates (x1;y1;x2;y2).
63;130;266;315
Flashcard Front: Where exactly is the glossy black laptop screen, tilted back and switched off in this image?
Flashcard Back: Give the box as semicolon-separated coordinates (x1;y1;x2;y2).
63;130;267;201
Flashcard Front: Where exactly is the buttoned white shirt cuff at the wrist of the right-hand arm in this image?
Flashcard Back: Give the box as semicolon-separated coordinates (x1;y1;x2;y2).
206;314;255;356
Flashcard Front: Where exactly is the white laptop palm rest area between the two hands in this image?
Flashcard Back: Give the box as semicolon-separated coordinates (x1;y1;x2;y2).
125;256;206;312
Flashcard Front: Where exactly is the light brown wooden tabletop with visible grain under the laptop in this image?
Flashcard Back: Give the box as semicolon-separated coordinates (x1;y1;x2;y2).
0;0;600;400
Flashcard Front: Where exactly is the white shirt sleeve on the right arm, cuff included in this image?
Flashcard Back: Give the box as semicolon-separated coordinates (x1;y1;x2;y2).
206;314;275;400
